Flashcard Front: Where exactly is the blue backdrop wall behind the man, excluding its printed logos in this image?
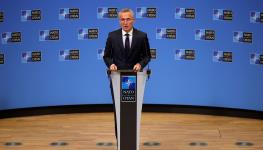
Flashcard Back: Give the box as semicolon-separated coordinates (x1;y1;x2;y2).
0;0;263;111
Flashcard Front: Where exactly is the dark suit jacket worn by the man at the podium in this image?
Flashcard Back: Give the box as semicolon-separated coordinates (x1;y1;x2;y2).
103;28;151;70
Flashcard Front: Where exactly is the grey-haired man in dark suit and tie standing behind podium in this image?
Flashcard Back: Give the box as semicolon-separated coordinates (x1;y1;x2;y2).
103;9;151;138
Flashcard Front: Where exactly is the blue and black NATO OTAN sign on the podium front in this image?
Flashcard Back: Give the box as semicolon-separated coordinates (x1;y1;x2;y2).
121;75;137;102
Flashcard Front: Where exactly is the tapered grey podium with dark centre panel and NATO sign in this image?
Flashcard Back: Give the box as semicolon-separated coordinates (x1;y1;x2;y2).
109;70;150;150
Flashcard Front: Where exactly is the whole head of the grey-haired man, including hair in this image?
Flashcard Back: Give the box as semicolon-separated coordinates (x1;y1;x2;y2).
119;8;134;32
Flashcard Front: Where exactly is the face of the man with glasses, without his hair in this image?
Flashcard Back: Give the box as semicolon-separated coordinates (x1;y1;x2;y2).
119;12;134;32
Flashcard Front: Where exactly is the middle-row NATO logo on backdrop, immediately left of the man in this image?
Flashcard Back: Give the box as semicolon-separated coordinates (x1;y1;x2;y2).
78;28;99;40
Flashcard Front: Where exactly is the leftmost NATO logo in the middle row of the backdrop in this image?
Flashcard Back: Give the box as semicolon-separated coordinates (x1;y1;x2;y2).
2;32;21;44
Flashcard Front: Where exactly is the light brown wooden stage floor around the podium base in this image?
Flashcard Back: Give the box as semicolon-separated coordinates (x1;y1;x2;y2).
0;112;263;150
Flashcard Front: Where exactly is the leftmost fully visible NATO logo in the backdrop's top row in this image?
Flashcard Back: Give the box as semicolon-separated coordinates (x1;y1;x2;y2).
21;9;41;22
